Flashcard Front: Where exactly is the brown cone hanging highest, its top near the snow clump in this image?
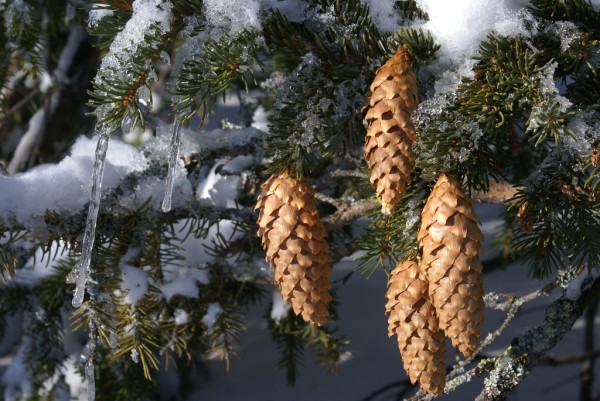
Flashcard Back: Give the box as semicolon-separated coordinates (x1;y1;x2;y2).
365;47;418;214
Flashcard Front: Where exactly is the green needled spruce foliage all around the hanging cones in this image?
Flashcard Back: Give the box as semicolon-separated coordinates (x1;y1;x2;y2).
0;0;600;400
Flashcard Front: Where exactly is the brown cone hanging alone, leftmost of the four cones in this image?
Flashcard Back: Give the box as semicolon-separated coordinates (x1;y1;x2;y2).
256;172;331;325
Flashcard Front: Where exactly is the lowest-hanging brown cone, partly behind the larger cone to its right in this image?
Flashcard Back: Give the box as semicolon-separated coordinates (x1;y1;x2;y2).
385;260;446;395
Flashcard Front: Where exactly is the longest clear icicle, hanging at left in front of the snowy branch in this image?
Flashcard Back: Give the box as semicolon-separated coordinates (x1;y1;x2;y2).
71;132;110;308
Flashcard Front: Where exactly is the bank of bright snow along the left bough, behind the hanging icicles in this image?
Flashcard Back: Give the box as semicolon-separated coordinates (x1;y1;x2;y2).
0;124;264;230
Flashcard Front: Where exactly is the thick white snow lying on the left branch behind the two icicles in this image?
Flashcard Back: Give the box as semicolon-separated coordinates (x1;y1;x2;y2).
0;125;263;231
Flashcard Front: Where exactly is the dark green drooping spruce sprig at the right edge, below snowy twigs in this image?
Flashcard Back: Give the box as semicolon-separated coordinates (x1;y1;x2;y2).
510;150;600;277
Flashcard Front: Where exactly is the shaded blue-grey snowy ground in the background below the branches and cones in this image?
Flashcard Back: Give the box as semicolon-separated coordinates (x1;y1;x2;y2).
188;205;600;401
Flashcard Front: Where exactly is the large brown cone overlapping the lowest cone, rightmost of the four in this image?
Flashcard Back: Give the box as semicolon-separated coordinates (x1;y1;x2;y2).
418;173;484;357
